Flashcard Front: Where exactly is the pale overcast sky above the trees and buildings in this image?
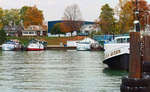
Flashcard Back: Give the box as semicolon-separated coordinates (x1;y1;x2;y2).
0;0;150;21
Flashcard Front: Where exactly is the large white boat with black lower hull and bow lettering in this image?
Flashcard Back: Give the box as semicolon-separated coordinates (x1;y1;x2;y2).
103;36;130;70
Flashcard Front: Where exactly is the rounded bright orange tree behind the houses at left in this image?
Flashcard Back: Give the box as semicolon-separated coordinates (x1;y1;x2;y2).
23;6;44;27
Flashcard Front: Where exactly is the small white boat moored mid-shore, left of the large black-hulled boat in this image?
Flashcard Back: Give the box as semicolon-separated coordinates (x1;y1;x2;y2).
76;41;91;51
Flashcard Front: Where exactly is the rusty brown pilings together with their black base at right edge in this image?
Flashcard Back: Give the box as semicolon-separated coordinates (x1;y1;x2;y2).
120;32;150;92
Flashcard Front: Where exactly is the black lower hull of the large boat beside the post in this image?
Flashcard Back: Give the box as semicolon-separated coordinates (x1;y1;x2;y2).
103;54;129;70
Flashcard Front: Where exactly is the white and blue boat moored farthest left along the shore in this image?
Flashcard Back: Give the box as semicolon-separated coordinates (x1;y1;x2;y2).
2;39;22;51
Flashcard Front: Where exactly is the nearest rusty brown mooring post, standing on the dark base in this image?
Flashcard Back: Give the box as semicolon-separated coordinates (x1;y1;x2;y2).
129;32;142;78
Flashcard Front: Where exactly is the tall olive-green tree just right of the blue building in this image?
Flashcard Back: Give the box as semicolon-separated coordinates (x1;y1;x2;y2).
99;4;115;34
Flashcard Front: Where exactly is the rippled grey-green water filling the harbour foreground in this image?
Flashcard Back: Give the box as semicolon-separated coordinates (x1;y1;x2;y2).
0;50;126;92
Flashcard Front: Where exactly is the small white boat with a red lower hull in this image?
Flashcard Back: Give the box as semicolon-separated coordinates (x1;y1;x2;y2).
26;39;46;51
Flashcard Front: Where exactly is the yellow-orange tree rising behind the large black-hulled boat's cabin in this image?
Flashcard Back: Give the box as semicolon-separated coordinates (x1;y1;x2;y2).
118;1;134;34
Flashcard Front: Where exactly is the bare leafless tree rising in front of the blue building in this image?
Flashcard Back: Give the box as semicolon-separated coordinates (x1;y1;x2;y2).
63;4;83;33
